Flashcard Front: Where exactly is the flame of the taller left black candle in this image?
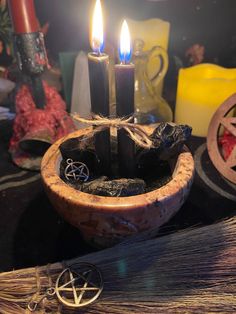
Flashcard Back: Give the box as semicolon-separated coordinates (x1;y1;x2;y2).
91;0;103;54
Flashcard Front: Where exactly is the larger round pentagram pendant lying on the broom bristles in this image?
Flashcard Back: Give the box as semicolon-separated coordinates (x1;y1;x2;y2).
55;263;103;308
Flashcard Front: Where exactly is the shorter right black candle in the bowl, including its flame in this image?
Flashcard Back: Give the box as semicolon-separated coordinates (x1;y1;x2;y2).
115;21;135;178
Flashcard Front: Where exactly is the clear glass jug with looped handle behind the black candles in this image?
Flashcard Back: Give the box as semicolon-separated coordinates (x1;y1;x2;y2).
133;38;173;124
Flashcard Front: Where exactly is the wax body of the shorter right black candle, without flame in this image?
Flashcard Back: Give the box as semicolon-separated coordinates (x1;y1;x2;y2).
115;64;136;178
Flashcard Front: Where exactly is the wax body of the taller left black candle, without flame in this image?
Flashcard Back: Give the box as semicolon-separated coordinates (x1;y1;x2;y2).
88;53;111;175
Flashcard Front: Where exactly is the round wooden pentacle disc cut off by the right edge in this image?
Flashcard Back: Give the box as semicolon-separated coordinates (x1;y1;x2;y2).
207;94;236;184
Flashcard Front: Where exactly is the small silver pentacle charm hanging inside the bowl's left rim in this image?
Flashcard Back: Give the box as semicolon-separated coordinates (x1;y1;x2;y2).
65;159;89;182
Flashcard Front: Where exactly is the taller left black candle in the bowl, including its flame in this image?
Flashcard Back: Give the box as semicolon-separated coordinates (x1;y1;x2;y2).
88;0;111;175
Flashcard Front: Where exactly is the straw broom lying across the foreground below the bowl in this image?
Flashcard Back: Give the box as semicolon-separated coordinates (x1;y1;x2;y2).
0;218;236;314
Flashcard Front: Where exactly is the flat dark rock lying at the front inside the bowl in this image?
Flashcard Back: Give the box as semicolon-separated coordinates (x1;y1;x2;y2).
82;179;146;197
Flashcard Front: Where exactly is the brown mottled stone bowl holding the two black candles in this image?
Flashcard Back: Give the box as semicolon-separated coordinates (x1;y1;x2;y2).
41;129;194;247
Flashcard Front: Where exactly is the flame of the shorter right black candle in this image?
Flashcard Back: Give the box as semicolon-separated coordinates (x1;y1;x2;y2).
120;20;131;64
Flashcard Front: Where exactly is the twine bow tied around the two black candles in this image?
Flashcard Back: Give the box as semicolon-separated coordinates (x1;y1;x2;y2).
72;114;154;149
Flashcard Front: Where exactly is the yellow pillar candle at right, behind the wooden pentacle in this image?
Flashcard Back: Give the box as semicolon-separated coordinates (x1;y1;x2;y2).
175;64;236;137
